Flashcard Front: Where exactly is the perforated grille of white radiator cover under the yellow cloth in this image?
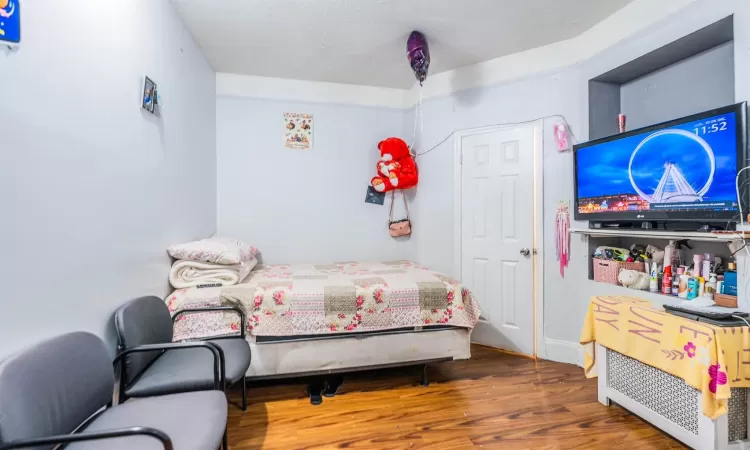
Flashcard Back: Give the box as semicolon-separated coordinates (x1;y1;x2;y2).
607;350;747;442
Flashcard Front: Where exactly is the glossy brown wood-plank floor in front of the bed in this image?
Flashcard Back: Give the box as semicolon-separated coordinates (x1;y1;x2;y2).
229;346;685;450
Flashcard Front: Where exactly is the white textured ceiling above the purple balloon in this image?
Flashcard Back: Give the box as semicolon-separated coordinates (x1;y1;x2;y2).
172;0;632;88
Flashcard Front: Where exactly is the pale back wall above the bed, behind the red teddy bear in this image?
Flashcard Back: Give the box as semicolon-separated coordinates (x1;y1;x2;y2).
216;96;416;263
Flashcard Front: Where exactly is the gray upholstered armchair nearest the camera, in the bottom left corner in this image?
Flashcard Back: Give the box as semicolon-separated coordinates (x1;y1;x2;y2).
0;332;227;450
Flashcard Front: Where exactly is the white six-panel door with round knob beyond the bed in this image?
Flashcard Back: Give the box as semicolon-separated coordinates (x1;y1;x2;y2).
461;125;534;355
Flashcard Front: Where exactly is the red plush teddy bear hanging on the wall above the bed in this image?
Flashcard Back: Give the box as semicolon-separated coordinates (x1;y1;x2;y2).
370;137;419;192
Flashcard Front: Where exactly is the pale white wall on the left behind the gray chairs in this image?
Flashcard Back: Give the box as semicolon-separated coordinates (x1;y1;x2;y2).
0;0;216;359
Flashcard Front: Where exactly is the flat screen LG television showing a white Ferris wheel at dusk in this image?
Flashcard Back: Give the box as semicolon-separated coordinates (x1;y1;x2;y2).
574;103;748;224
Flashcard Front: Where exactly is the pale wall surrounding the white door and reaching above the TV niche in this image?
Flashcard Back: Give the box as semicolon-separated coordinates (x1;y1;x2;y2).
414;0;750;363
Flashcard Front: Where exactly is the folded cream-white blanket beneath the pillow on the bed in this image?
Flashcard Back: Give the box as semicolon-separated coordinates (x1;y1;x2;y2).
169;258;258;289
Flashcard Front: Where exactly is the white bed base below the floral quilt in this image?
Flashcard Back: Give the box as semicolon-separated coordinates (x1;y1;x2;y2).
247;327;471;385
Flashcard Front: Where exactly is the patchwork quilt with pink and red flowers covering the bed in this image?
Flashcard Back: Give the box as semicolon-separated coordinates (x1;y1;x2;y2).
166;261;479;340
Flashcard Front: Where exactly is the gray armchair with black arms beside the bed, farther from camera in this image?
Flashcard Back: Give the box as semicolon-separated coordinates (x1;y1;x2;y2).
115;297;250;411
